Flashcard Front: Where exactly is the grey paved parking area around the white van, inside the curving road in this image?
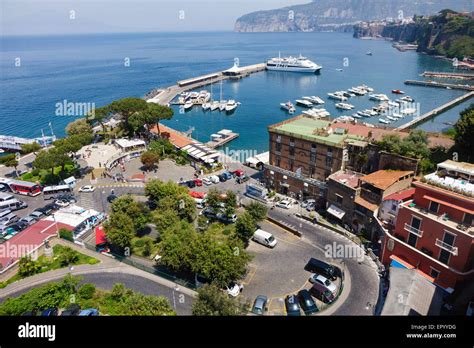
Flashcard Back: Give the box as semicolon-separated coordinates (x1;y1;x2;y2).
242;221;340;315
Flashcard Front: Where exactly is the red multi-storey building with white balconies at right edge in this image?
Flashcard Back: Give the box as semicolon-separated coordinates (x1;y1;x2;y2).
381;161;474;291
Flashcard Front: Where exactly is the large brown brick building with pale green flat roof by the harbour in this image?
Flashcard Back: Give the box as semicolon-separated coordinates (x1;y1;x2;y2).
264;116;367;205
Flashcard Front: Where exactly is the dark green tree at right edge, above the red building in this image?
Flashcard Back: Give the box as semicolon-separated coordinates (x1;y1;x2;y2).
454;104;474;163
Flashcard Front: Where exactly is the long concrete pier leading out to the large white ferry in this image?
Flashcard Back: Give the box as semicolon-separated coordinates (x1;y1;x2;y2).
147;63;266;105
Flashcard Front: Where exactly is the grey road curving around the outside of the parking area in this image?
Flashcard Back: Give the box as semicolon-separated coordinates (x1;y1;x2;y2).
269;208;379;315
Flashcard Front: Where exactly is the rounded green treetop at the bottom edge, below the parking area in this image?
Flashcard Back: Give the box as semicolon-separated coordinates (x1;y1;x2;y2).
192;285;242;316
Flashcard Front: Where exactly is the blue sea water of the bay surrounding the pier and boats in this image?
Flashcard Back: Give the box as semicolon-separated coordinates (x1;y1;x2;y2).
0;32;467;152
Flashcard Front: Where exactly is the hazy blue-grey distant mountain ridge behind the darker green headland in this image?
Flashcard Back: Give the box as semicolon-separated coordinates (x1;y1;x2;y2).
234;0;474;32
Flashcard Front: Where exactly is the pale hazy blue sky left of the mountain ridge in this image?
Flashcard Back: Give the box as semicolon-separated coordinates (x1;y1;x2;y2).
0;0;310;35
